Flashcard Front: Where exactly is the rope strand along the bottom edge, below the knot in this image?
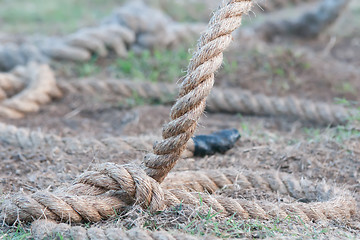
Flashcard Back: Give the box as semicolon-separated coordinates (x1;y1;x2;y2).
31;220;214;240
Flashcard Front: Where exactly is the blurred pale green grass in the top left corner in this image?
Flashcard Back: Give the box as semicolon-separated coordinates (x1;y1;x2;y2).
0;0;124;34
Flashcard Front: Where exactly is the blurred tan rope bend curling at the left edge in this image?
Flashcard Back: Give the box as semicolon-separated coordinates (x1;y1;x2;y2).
0;63;62;118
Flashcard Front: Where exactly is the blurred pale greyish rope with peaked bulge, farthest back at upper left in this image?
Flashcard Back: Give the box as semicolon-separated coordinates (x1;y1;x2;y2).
0;1;205;71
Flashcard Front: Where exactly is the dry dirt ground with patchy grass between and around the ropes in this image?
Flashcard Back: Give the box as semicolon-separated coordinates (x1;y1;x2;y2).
0;0;360;239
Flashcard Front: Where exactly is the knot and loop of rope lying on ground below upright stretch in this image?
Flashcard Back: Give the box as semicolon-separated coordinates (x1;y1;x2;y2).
2;166;356;224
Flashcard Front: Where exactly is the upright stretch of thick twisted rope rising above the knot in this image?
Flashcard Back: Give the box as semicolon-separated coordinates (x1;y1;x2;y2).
144;0;252;182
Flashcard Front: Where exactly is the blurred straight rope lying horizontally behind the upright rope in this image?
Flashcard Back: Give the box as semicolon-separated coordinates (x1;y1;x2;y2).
58;80;358;125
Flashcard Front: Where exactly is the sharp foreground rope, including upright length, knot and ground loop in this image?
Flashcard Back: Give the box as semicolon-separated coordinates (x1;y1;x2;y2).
0;0;356;239
